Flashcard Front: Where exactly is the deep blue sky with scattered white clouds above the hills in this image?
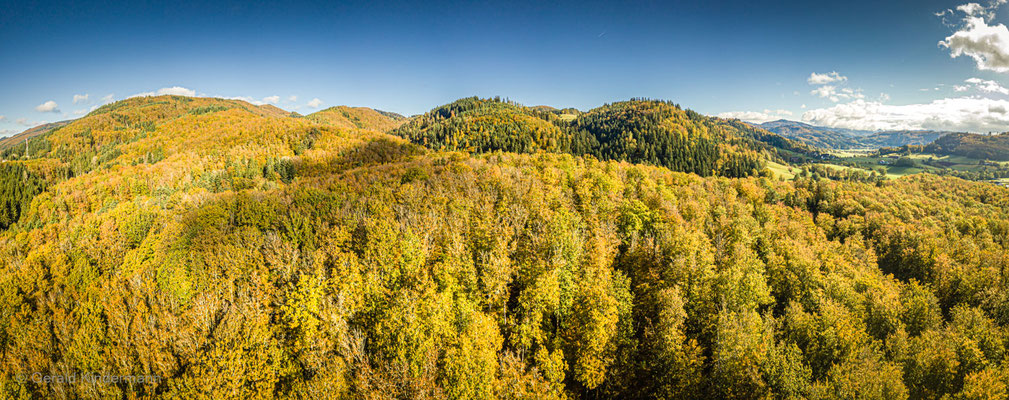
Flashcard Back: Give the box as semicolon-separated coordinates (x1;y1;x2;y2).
0;0;1009;135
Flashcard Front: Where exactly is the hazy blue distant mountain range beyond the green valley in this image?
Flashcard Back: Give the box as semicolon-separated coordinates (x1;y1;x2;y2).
754;119;954;149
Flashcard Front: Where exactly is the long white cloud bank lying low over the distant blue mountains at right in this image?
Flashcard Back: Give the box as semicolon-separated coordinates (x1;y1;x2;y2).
802;97;1009;132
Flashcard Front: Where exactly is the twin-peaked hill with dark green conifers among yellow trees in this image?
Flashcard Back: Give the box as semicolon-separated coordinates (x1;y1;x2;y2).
393;97;814;177
